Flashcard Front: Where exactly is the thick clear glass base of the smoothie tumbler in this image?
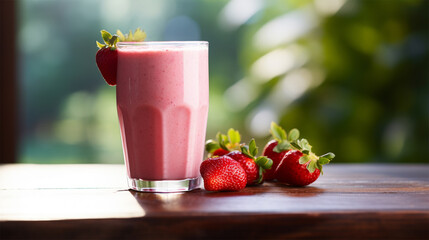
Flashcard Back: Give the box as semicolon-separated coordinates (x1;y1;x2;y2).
128;177;201;193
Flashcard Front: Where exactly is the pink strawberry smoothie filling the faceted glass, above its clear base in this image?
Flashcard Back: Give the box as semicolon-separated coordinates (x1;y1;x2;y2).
116;42;209;180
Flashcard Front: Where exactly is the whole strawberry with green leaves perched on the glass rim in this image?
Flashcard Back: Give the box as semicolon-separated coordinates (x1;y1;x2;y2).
95;28;146;86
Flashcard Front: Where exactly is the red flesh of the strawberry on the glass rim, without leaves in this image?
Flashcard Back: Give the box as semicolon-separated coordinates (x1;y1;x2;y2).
95;46;118;86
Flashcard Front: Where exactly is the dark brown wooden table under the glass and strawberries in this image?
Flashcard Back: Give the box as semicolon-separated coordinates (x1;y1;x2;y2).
0;164;429;239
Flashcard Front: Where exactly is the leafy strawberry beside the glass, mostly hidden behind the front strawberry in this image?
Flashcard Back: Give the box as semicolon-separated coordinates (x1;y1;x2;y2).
206;128;243;157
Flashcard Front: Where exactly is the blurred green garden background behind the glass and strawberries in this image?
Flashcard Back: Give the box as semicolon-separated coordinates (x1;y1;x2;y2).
17;0;429;163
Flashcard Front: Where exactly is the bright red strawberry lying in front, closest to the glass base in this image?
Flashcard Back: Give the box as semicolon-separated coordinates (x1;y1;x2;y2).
200;156;247;191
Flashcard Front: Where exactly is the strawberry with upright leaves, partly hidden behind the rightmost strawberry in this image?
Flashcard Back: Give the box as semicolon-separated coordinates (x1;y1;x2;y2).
262;122;299;180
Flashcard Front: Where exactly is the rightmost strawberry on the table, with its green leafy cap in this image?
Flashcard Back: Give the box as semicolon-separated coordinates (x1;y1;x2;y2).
275;150;334;186
